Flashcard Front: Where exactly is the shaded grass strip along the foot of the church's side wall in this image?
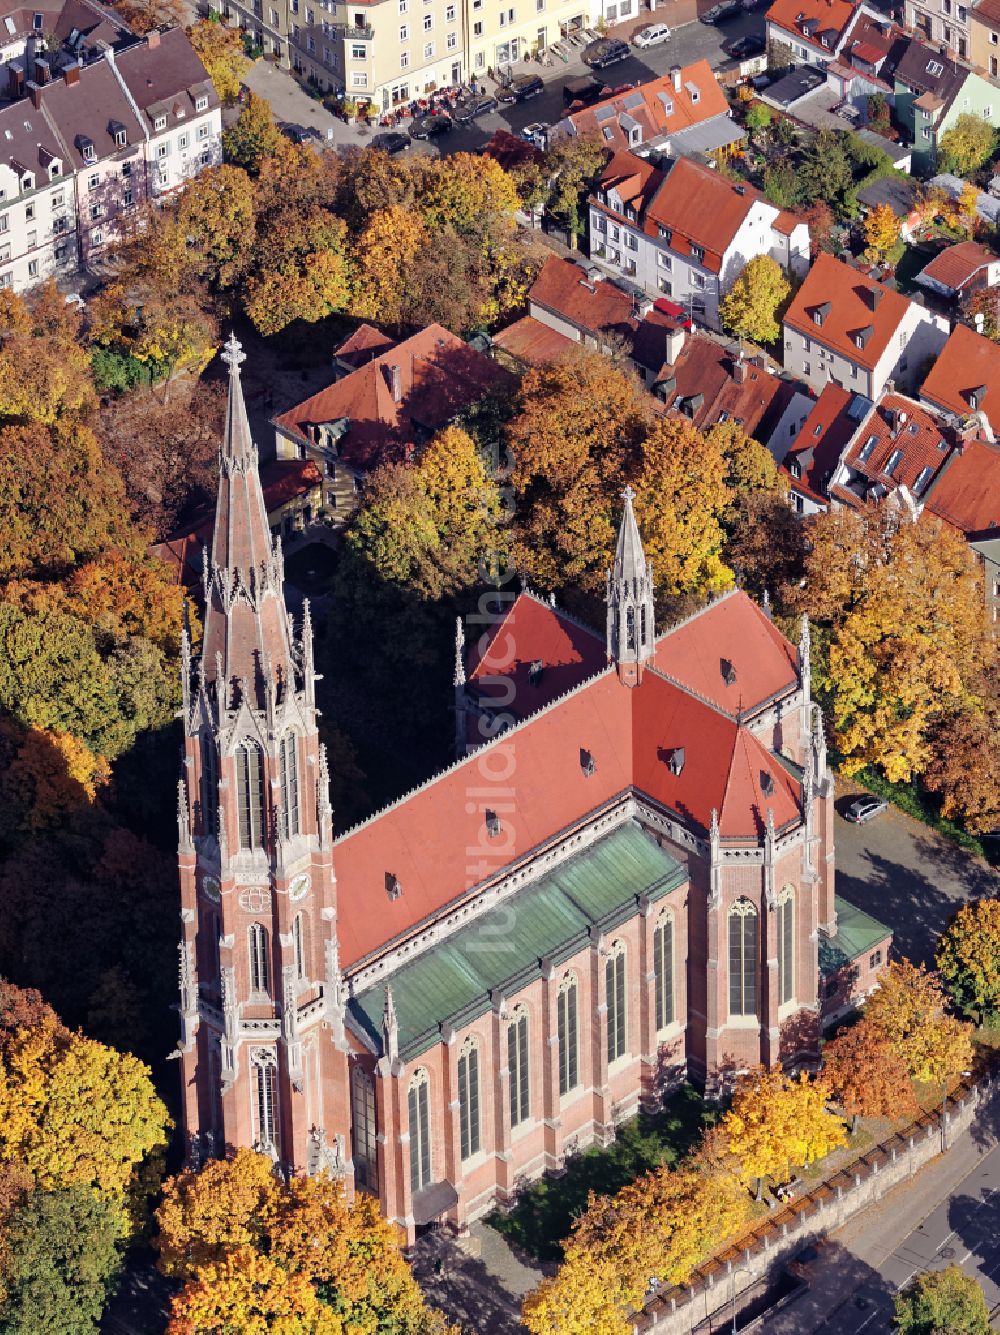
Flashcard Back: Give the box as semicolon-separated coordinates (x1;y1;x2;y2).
486;1085;720;1260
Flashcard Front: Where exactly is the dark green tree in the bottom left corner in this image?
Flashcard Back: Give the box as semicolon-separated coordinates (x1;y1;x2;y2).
0;1187;121;1335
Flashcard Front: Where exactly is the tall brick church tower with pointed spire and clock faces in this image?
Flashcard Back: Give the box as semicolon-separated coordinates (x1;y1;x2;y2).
178;336;350;1176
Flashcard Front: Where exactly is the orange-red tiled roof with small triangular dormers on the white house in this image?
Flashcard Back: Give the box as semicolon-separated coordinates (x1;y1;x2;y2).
785;251;909;371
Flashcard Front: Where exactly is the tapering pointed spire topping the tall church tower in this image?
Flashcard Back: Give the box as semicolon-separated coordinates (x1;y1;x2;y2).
203;334;294;709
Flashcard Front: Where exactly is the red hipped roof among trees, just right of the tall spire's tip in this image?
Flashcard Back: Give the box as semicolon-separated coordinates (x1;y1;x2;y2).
274;324;514;470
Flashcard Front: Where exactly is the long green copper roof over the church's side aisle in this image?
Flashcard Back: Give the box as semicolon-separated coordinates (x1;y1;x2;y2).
350;824;688;1061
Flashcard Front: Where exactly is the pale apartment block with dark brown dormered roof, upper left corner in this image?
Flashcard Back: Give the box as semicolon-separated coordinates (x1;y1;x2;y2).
0;28;222;291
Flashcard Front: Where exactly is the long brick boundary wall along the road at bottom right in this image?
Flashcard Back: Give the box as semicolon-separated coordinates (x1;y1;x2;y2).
633;1061;997;1335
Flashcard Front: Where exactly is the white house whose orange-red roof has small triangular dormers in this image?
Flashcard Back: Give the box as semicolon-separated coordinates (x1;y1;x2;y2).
785;254;948;399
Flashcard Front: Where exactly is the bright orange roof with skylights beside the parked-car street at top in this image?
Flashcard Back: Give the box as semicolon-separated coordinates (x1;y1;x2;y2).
563;60;729;148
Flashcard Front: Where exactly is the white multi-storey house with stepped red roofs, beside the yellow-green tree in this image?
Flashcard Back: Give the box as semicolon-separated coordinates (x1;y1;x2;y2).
590;152;809;328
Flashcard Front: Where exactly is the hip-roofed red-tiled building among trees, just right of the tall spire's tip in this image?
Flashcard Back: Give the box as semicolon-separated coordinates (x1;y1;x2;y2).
274;324;514;521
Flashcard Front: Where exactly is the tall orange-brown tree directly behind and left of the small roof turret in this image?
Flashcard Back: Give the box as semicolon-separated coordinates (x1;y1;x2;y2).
506;350;651;593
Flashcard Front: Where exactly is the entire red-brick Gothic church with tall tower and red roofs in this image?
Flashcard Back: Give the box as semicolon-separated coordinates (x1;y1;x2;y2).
178;338;889;1240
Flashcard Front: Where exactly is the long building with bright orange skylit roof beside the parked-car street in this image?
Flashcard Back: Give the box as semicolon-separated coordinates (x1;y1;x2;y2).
553;60;746;158
